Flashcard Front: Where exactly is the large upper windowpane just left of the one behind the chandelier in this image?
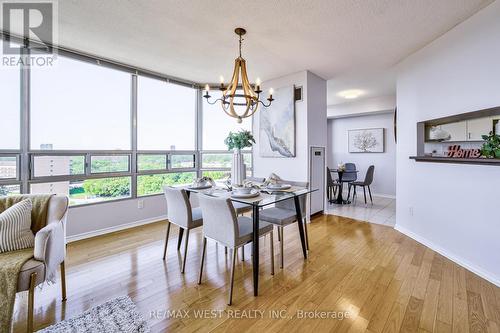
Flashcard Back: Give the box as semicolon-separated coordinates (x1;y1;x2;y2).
137;76;196;150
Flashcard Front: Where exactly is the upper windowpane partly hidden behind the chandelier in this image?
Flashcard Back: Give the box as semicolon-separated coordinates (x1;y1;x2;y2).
203;92;252;151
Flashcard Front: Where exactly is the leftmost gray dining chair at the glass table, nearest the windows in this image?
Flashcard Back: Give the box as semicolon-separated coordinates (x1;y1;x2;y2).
163;186;203;273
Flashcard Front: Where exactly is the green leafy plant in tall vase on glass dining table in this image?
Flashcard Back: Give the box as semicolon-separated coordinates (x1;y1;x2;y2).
224;130;255;186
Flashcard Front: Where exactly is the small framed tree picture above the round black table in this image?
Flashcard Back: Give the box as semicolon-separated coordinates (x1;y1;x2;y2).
348;128;385;153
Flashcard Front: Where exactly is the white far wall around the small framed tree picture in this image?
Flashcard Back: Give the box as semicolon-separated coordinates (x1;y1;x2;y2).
328;111;396;197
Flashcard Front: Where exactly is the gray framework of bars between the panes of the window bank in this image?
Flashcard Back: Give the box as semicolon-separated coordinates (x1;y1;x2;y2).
0;34;253;208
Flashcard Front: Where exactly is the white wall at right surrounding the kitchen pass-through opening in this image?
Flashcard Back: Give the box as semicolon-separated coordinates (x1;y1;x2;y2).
396;1;500;286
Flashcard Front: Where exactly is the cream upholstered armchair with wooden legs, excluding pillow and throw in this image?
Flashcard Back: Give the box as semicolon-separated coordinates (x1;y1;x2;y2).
5;195;69;332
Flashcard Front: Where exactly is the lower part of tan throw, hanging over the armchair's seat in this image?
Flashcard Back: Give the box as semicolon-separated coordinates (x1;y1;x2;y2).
0;248;33;333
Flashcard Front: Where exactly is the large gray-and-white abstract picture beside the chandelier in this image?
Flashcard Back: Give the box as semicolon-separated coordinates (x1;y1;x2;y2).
259;86;295;158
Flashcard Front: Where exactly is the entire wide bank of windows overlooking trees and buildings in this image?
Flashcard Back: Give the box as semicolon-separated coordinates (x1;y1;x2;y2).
0;40;252;206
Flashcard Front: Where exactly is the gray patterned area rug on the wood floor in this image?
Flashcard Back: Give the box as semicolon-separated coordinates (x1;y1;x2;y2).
38;296;149;333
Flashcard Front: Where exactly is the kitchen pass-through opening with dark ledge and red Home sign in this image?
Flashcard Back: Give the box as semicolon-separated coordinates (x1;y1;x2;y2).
410;107;500;165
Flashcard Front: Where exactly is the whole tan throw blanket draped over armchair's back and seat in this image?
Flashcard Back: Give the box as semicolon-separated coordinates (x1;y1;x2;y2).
0;195;52;333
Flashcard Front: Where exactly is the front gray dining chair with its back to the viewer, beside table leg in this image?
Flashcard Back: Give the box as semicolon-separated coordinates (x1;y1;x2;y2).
198;194;274;305
